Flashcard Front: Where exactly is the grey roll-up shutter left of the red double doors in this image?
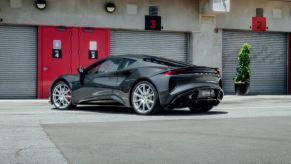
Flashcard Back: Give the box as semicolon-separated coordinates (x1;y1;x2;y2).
0;26;37;98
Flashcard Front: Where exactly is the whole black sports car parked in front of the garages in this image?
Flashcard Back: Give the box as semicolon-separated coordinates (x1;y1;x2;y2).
50;55;224;115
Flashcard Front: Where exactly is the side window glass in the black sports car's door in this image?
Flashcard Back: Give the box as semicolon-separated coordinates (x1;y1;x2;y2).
89;59;122;74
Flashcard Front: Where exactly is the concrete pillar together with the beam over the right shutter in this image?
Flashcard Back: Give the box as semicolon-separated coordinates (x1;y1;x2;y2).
193;0;291;69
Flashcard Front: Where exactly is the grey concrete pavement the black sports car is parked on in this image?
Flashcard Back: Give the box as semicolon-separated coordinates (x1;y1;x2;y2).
0;96;291;164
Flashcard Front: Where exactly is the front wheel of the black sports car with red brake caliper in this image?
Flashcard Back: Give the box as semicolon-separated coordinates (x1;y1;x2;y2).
51;81;76;110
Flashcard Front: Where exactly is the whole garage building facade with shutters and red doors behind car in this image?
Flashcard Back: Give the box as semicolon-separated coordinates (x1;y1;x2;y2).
0;0;291;98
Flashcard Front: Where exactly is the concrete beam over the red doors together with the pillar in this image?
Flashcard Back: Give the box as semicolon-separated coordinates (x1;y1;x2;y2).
0;0;226;68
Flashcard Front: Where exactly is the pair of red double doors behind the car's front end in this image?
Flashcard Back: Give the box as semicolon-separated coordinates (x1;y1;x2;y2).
38;26;110;98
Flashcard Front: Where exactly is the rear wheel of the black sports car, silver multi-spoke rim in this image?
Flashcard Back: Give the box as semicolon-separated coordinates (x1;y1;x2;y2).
131;81;161;115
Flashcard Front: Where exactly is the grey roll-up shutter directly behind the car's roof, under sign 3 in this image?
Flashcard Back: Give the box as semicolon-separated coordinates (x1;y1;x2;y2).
110;31;188;62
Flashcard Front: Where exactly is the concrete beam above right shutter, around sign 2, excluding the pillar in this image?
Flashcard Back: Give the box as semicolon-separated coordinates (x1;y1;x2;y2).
217;0;291;32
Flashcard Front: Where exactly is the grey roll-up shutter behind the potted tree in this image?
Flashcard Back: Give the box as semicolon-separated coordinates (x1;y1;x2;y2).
223;31;287;95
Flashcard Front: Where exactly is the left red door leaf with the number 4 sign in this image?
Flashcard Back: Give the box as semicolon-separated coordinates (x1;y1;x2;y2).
38;26;72;98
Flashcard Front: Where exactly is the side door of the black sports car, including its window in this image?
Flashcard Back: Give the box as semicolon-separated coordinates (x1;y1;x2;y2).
76;58;121;101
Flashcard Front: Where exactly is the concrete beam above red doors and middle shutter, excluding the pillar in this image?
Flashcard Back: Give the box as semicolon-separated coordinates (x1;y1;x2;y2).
0;0;199;31
